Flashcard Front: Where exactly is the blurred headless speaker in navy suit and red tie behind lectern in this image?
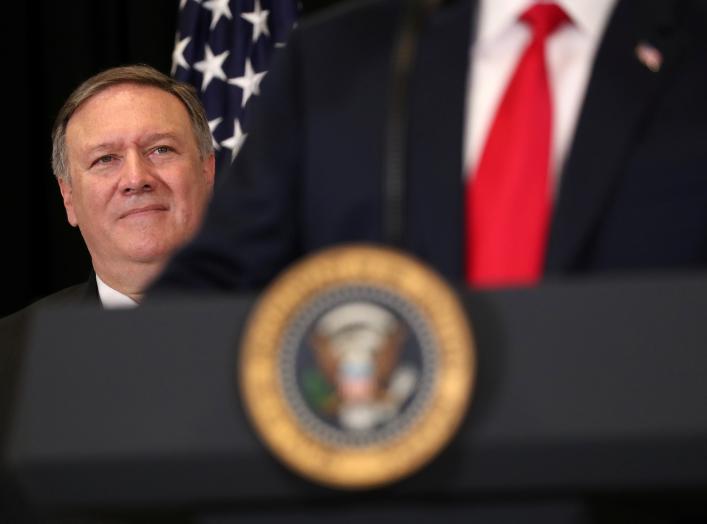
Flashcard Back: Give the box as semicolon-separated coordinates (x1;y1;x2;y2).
152;0;707;290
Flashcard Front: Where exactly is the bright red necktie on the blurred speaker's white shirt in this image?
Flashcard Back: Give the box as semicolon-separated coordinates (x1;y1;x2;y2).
466;4;567;286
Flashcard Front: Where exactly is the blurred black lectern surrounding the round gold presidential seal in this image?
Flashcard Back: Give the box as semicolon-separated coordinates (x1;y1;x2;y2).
9;274;707;522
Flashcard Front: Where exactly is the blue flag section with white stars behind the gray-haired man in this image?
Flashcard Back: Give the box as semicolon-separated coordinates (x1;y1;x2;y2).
172;0;298;171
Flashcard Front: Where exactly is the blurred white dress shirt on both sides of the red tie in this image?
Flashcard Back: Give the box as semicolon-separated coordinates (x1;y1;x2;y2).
464;0;616;187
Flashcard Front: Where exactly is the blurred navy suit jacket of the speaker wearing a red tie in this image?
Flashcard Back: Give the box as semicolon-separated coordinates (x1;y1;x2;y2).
152;0;707;289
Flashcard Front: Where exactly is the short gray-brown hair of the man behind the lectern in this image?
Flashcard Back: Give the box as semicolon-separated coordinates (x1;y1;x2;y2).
52;64;214;182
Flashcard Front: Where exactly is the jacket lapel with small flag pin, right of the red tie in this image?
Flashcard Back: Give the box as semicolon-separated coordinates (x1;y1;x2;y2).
546;0;680;273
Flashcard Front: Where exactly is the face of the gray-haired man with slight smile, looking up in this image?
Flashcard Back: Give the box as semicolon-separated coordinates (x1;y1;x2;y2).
59;84;214;268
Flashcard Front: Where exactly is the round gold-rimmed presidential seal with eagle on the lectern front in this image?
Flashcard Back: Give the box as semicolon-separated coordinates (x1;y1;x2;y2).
239;246;476;489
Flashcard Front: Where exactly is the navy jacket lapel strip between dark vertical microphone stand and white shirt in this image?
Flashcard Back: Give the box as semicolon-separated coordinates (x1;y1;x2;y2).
406;0;475;280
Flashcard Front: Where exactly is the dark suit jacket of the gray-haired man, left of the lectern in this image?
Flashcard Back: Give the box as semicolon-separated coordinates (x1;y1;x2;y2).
0;275;100;522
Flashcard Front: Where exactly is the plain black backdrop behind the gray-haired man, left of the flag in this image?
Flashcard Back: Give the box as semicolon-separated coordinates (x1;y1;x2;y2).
0;0;335;317
